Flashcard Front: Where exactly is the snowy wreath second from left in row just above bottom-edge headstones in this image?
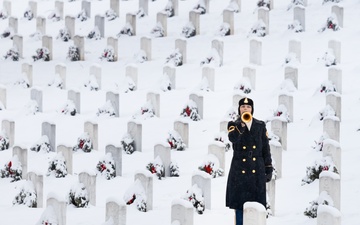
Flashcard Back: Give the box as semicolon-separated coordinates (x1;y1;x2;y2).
68;183;90;208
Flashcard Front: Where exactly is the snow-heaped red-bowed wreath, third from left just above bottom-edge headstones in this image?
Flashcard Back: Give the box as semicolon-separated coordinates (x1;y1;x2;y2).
123;179;147;212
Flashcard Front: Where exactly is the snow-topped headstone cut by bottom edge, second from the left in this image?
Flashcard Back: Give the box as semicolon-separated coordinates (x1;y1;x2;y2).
105;198;126;225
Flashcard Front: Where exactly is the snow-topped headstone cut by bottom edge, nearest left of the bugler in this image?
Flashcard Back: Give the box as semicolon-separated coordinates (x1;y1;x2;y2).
171;199;194;225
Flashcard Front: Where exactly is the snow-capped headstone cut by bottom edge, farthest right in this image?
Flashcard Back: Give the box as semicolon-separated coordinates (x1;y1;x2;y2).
317;205;341;225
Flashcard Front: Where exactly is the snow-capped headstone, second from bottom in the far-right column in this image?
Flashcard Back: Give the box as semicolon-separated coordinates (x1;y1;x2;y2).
319;170;341;210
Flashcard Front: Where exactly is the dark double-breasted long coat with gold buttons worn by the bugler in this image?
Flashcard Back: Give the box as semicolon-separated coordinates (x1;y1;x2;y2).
226;118;271;210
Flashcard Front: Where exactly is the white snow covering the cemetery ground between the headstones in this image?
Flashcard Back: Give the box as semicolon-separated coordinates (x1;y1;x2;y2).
0;0;360;225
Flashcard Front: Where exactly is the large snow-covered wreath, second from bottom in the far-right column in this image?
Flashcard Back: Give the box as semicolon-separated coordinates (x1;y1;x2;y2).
301;156;339;185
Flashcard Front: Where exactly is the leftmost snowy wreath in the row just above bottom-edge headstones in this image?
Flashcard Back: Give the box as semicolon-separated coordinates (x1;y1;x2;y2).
12;181;37;208
